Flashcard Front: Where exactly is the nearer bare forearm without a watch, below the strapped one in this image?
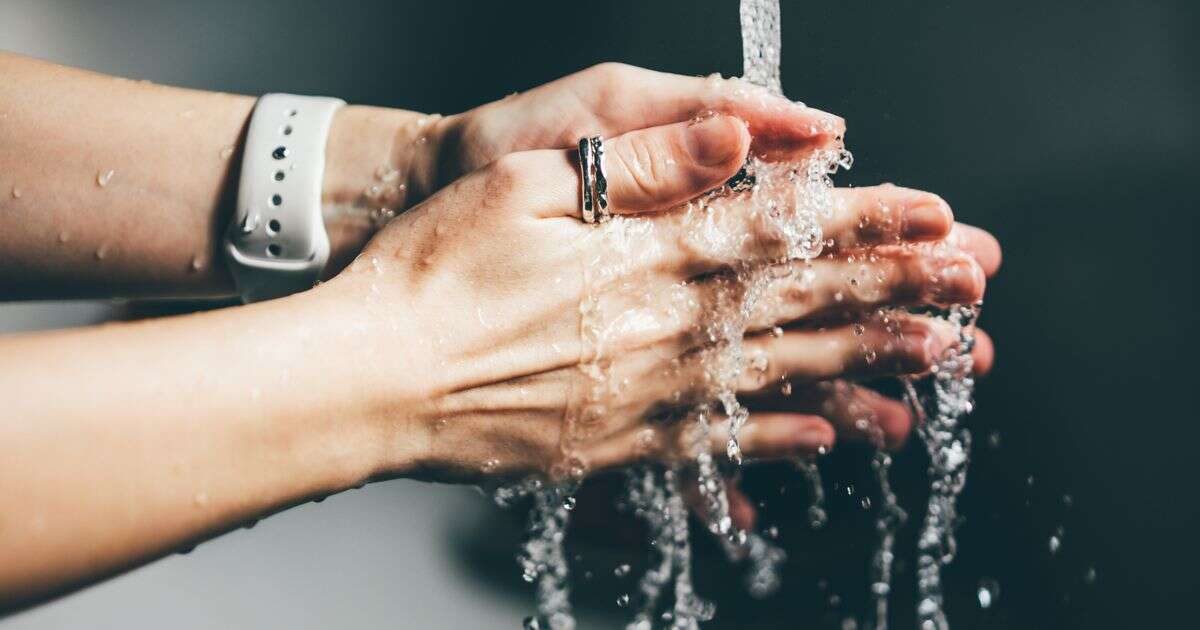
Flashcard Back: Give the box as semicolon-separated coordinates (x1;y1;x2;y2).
0;283;417;611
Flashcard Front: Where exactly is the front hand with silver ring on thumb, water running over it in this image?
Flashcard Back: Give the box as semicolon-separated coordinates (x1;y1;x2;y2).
318;105;998;481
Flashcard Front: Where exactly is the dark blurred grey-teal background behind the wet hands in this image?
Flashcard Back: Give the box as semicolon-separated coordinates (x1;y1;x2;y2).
0;0;1200;629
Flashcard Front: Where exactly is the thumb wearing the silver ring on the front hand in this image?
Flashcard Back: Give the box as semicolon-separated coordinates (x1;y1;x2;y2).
528;115;750;216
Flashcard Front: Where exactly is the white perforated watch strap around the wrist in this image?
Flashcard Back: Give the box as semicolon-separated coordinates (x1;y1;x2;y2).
224;94;346;302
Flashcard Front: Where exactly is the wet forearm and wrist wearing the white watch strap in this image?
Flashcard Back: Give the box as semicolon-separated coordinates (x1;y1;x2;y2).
0;53;448;299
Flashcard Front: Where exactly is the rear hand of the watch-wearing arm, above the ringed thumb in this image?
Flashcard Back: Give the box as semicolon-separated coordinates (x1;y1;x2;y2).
324;64;844;271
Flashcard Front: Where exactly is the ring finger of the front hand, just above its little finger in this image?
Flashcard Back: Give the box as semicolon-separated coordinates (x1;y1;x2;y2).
739;316;958;392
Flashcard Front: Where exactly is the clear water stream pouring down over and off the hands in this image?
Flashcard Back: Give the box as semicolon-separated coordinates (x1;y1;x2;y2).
511;0;978;630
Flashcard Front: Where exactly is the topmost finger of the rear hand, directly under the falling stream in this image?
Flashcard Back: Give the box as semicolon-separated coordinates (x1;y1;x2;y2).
561;64;846;160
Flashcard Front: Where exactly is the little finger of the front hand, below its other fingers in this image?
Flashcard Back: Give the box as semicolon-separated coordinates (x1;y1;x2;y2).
582;413;835;470
